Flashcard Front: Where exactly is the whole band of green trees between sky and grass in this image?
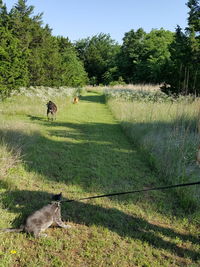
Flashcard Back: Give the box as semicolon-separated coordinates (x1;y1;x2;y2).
0;0;200;97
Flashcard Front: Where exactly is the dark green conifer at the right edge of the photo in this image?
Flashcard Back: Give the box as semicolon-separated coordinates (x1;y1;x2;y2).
163;0;200;95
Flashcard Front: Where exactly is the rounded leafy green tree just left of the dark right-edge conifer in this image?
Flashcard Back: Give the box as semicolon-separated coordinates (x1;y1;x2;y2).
118;28;173;83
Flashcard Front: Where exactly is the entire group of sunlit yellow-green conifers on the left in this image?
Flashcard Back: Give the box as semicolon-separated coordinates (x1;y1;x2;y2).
0;0;88;97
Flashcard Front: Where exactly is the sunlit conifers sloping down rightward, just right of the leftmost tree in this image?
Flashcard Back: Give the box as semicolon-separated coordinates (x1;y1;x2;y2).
10;0;86;89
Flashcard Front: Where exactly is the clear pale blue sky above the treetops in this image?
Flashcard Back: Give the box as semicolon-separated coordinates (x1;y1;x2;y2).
3;0;189;43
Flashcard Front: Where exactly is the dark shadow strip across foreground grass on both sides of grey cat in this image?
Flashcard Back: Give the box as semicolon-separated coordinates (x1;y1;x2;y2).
2;190;200;260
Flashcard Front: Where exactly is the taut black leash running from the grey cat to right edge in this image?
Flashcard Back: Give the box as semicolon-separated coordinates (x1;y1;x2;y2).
60;181;200;202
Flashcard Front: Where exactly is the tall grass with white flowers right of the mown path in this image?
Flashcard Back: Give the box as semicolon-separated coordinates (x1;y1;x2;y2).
105;90;200;216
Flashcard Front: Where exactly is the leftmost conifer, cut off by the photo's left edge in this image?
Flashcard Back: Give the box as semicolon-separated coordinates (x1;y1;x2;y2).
0;1;28;97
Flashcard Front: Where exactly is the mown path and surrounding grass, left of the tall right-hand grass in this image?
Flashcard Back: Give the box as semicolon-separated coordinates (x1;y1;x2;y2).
0;89;200;267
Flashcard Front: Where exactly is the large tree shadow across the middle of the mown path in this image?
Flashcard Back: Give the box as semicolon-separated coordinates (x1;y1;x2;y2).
0;115;199;217
